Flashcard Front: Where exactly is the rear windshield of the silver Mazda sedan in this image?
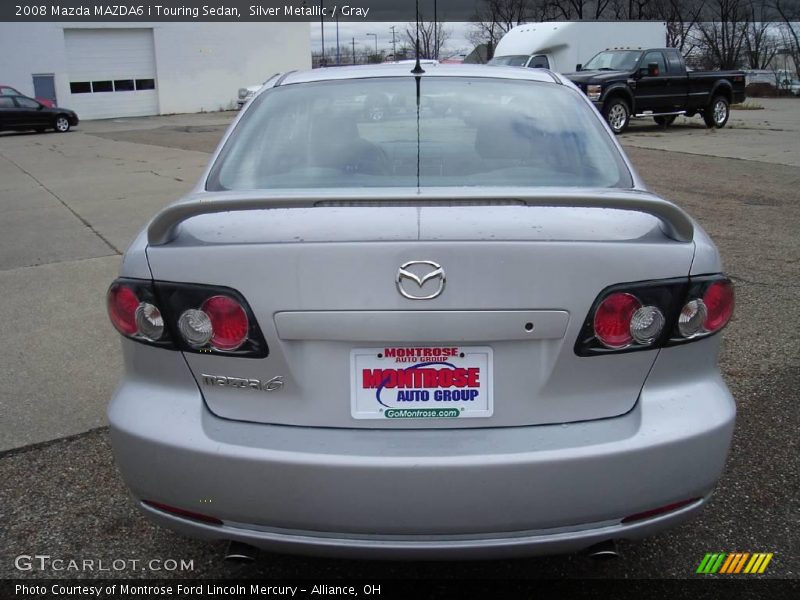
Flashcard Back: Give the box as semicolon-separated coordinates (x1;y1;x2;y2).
207;77;632;190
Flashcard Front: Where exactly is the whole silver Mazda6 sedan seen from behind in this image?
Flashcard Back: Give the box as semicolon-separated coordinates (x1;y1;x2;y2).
108;65;735;558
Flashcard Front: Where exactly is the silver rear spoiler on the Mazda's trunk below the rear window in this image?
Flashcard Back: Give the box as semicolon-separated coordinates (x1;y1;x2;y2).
147;188;694;246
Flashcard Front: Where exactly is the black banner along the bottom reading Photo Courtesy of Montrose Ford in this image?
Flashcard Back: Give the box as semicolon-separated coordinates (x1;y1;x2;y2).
0;575;800;600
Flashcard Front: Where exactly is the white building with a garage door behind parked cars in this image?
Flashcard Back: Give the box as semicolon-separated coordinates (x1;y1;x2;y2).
0;23;311;119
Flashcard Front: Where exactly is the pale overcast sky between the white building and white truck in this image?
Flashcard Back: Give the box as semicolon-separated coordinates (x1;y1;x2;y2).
311;21;473;58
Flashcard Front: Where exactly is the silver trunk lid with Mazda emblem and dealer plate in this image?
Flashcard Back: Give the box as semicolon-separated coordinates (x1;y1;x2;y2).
147;195;694;428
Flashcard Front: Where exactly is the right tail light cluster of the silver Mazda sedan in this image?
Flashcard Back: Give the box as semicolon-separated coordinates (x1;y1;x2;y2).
575;275;733;356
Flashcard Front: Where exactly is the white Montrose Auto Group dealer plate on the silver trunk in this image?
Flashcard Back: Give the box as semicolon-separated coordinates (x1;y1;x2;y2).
350;346;493;419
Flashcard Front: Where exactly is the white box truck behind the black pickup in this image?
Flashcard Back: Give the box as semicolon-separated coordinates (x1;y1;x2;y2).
489;21;667;73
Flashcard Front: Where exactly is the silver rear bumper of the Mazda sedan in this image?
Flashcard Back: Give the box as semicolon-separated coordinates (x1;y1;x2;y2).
109;339;735;558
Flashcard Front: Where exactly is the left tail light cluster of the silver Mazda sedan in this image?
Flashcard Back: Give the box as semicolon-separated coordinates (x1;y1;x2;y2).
107;278;269;358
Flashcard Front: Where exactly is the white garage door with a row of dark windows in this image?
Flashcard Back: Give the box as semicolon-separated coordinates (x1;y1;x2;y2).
63;29;158;119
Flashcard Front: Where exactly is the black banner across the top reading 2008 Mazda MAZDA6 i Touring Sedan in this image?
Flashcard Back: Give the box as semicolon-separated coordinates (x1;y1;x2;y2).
0;0;788;22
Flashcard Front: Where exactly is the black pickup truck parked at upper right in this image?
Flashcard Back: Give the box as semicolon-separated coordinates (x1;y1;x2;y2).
565;48;745;133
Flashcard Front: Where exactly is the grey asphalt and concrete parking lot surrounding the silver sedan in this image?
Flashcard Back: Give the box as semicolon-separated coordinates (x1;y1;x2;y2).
0;99;800;579
